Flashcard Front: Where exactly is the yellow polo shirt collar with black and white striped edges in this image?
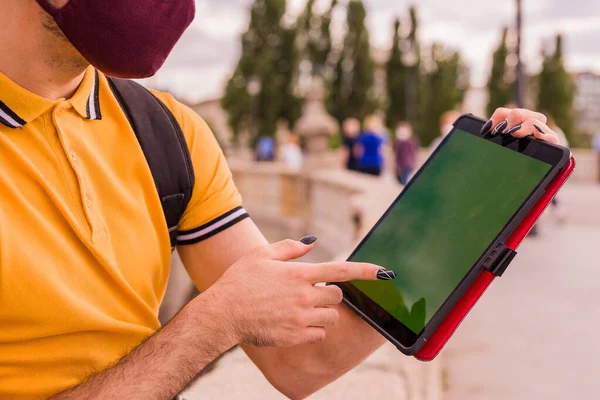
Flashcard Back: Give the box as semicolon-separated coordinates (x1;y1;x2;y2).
0;66;102;129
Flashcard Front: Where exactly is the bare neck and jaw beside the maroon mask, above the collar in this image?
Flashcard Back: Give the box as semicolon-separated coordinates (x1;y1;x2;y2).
0;0;87;100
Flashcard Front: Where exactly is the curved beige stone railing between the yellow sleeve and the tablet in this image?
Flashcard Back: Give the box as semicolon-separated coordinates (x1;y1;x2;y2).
230;160;400;258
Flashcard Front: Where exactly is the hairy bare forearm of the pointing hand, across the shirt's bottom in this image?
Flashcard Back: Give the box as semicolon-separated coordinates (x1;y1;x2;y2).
52;293;235;400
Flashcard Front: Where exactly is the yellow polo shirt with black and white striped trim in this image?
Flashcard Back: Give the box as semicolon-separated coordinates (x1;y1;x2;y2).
0;67;247;399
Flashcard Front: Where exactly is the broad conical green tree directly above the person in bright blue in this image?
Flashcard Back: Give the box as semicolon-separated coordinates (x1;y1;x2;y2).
327;0;376;122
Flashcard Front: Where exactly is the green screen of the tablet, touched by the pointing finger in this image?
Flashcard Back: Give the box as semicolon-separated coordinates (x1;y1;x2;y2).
352;130;551;334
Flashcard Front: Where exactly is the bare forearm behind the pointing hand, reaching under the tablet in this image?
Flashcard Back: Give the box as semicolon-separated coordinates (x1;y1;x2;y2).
244;305;385;399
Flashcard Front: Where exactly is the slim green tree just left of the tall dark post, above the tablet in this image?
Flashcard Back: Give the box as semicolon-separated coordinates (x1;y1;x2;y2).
487;27;514;115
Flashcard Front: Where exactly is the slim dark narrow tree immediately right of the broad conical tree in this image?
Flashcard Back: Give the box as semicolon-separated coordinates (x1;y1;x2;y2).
385;19;406;130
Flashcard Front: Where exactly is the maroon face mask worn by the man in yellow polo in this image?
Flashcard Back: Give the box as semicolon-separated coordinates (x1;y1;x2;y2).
37;0;196;78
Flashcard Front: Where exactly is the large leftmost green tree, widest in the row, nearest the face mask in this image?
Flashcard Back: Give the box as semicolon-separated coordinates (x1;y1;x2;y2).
222;0;301;139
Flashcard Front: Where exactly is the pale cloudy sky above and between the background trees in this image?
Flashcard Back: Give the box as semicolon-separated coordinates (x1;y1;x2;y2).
139;0;600;102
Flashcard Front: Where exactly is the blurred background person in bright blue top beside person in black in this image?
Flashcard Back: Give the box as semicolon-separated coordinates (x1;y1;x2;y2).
356;115;385;176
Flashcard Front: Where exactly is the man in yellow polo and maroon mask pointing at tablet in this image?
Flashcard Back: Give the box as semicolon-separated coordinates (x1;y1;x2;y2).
0;0;554;400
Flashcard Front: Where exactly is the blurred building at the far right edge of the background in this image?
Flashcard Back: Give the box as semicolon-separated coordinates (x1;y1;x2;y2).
575;72;600;133
